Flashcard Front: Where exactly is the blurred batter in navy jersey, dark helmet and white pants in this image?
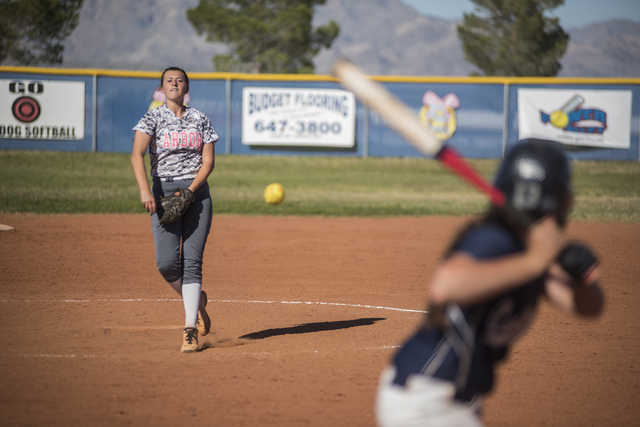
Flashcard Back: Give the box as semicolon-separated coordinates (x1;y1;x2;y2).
376;140;603;427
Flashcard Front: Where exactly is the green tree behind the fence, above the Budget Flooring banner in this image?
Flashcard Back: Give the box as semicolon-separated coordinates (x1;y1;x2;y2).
187;0;340;74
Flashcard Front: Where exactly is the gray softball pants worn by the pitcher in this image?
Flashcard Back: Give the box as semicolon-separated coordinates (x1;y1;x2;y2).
151;178;212;284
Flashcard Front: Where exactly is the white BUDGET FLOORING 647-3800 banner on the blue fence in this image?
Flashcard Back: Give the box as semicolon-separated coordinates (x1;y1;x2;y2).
242;87;356;147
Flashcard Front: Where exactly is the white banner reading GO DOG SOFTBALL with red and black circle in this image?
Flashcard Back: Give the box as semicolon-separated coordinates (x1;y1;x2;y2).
0;79;84;140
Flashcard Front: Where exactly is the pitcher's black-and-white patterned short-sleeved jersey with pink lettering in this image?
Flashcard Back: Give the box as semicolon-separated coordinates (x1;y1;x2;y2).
133;104;220;178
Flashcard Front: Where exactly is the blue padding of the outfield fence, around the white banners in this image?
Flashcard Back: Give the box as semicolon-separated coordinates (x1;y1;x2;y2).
0;69;640;161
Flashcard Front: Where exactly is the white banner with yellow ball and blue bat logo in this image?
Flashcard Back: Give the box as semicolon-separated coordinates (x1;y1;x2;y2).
518;89;631;148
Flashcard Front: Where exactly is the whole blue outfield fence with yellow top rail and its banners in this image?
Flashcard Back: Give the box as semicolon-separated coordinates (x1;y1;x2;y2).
0;67;640;161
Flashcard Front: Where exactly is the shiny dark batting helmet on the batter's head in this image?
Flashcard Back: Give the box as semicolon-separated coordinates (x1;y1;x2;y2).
494;139;573;225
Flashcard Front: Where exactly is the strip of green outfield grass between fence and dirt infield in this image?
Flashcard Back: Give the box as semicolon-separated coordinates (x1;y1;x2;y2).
0;150;640;222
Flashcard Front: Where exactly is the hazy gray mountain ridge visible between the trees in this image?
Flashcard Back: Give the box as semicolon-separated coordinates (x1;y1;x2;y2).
61;0;640;78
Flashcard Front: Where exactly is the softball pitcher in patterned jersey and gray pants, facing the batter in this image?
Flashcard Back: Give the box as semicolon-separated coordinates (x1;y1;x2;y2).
131;67;219;353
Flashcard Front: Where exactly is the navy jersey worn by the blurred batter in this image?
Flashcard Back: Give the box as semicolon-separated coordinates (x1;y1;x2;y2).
393;223;544;401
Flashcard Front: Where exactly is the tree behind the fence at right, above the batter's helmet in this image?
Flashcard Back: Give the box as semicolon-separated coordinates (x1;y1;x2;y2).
457;0;569;77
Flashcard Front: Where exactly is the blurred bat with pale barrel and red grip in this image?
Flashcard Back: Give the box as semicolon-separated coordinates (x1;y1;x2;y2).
333;60;506;207
